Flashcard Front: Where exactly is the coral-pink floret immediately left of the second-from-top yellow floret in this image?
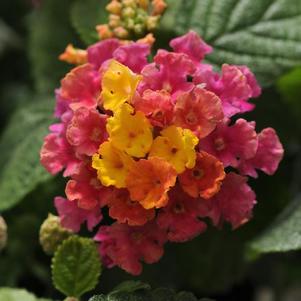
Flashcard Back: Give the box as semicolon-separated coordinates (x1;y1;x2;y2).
66;107;108;156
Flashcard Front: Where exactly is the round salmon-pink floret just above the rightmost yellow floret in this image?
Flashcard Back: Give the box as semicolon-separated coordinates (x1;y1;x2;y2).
174;87;224;138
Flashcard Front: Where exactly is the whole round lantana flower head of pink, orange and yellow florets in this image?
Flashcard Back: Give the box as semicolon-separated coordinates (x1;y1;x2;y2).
41;31;283;275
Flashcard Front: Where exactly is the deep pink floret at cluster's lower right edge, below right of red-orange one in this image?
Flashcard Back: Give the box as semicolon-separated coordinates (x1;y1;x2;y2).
199;172;256;229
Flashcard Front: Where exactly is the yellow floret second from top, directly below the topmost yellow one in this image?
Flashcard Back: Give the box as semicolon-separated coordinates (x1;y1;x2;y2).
107;104;153;158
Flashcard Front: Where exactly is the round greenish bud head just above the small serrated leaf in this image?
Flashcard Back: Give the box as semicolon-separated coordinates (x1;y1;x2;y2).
40;214;73;255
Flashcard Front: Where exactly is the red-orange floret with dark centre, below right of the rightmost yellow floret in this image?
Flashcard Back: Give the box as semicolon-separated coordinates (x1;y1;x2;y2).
179;152;226;199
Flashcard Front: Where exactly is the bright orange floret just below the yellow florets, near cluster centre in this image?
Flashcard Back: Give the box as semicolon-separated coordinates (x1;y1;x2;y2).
126;157;177;209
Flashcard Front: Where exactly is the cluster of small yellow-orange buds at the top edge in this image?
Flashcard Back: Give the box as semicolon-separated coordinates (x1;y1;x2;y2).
96;0;167;42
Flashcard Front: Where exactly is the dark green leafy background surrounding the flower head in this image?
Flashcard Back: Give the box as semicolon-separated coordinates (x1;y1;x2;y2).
0;0;301;301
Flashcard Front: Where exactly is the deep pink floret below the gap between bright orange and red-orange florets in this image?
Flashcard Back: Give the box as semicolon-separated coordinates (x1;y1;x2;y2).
157;186;207;242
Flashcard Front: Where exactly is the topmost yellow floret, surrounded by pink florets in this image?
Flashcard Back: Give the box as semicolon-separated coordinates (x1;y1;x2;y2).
101;60;142;112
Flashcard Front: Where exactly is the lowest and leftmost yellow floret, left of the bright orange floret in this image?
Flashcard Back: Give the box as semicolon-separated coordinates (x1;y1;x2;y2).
92;141;134;188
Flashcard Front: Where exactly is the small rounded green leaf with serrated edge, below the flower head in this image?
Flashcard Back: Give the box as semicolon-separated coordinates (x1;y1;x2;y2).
52;236;101;298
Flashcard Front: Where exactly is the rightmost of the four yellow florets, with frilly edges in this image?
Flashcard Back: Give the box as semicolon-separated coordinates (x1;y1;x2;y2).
149;125;199;173
